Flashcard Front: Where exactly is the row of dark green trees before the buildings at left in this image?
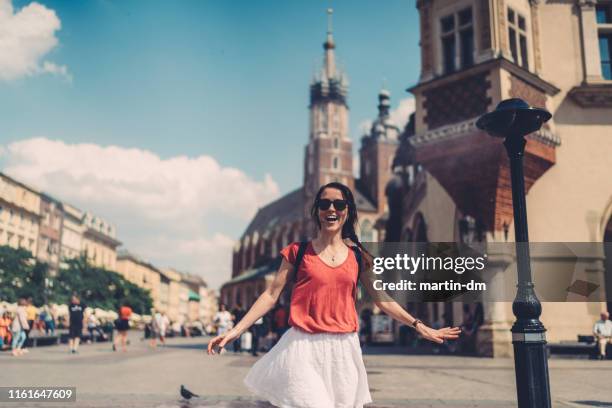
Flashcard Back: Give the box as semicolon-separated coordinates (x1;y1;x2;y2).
0;246;152;314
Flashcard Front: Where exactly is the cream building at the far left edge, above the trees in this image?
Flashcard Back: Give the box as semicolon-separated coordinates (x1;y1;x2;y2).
0;173;41;256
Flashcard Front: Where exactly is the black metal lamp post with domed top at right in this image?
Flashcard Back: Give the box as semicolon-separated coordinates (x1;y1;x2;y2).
476;99;551;408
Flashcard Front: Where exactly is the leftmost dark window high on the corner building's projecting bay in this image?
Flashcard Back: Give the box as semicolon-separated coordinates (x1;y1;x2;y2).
440;7;474;74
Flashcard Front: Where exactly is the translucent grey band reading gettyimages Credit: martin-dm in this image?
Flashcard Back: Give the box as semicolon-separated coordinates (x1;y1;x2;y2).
364;242;612;302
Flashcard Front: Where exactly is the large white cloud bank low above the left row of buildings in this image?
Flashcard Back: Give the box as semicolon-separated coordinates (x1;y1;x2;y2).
3;138;279;287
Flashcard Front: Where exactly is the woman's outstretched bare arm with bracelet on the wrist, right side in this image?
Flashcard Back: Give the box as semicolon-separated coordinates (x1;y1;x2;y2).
360;268;461;343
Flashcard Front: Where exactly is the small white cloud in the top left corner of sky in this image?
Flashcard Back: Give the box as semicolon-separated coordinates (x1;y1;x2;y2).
0;0;71;81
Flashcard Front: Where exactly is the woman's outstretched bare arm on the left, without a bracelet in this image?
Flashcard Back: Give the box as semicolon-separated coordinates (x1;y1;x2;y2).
208;258;293;354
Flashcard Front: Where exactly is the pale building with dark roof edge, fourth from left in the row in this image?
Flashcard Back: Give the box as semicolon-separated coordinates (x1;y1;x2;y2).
82;212;121;271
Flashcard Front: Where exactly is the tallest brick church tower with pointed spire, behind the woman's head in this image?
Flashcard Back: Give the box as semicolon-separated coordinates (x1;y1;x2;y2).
304;9;355;207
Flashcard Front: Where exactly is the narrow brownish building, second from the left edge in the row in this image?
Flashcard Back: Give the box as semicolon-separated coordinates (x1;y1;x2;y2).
36;193;64;275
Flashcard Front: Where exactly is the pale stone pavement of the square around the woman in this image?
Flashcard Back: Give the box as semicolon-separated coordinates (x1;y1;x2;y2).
0;333;612;408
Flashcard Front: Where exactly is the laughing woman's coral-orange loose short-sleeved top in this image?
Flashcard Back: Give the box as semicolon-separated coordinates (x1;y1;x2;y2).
281;242;358;333
